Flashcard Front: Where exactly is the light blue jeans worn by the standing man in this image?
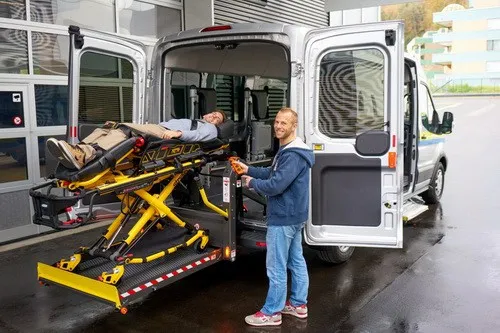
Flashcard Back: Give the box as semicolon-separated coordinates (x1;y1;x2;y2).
260;223;309;315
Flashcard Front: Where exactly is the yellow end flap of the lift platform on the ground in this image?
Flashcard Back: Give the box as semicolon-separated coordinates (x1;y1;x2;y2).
38;262;121;309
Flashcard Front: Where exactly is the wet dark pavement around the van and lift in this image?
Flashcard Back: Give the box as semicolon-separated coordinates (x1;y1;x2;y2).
0;97;500;333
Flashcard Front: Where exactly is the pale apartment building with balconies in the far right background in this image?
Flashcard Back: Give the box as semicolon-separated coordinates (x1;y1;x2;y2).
432;0;500;88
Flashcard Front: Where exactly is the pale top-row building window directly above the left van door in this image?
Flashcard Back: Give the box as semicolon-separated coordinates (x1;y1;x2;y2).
30;0;116;32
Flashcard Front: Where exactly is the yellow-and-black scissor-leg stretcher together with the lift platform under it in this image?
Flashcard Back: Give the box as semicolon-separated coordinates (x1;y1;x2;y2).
30;121;239;313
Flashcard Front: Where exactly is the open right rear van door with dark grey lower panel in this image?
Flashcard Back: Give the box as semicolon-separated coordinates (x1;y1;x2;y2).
304;22;404;248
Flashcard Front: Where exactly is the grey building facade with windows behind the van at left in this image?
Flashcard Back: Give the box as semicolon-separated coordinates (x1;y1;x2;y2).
0;0;329;243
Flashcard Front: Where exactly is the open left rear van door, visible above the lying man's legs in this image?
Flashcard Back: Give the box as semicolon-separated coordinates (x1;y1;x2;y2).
68;26;147;144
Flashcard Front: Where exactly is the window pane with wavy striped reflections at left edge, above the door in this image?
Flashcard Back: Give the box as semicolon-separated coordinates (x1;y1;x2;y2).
0;28;28;74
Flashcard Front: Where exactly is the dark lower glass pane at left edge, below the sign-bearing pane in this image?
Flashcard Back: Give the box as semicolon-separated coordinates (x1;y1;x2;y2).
0;138;28;183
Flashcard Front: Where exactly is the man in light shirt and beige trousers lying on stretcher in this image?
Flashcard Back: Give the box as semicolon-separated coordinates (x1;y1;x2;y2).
47;110;226;170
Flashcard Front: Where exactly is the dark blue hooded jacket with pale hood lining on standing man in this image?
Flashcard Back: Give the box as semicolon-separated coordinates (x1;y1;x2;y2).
248;138;314;225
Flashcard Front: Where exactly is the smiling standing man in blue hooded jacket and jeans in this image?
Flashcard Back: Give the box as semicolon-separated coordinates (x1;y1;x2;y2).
238;108;314;326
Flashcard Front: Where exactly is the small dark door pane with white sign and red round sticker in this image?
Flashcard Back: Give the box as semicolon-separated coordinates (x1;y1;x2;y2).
0;91;25;128
